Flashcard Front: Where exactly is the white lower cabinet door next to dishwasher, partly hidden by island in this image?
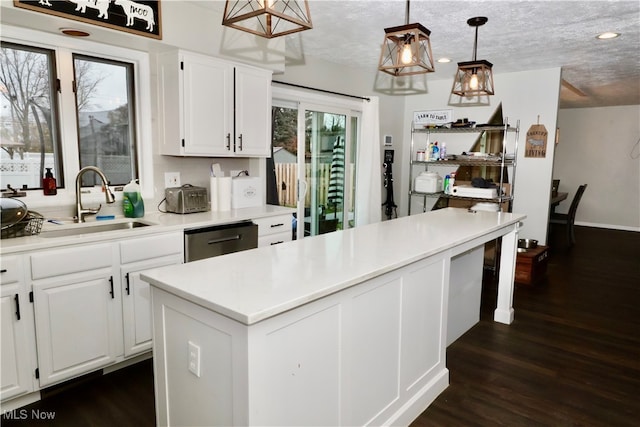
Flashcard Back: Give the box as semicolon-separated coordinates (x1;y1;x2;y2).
122;255;182;357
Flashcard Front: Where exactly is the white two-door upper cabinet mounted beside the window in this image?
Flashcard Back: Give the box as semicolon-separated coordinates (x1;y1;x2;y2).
158;51;271;157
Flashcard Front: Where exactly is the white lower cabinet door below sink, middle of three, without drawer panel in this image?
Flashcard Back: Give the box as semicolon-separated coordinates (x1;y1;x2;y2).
33;269;122;387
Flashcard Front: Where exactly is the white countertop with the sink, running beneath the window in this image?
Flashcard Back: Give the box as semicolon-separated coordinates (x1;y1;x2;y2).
0;205;295;255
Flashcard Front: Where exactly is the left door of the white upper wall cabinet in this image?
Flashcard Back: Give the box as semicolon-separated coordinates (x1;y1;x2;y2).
181;54;233;156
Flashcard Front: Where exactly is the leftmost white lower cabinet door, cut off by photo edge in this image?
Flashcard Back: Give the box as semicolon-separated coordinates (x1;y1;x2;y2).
0;283;33;400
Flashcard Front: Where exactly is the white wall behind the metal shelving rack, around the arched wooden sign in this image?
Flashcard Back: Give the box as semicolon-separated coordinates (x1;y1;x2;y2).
400;68;560;246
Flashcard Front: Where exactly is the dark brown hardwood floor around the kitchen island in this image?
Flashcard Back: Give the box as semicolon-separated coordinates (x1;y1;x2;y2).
1;227;640;427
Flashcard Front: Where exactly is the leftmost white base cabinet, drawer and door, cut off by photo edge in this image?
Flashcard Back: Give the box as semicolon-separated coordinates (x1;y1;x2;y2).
0;256;35;401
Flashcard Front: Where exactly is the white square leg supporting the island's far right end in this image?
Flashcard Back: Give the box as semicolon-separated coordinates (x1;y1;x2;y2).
493;225;518;325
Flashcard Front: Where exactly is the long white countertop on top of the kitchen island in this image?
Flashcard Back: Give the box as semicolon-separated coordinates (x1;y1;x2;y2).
141;208;525;325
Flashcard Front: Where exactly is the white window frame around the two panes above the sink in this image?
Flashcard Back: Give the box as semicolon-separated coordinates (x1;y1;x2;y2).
1;25;154;208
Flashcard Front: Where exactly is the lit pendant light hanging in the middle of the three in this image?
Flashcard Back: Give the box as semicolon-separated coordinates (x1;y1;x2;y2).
378;0;435;76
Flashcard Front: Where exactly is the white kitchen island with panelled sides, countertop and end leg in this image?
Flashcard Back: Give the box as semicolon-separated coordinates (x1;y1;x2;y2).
142;208;525;426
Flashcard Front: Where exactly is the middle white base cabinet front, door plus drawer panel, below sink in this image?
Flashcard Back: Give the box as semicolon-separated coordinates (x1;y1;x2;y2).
31;243;123;387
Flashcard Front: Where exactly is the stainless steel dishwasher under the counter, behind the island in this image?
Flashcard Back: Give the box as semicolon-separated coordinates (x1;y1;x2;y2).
184;221;258;262
